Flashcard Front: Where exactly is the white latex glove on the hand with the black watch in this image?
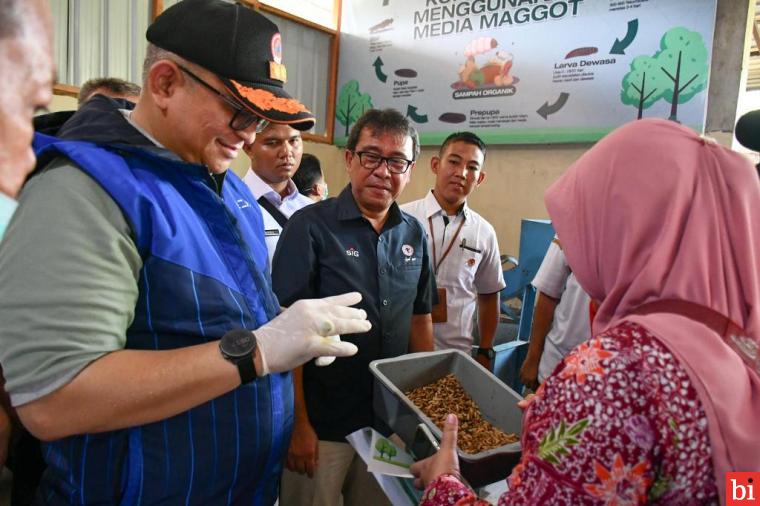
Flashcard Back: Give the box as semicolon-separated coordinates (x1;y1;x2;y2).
253;292;372;376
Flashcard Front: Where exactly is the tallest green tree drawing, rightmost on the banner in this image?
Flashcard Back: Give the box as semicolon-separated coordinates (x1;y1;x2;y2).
654;27;708;121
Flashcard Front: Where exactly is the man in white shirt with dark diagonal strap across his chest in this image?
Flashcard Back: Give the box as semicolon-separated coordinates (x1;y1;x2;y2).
243;124;314;270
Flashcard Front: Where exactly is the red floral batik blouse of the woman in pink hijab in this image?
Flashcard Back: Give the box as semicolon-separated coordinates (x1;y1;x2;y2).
421;322;718;506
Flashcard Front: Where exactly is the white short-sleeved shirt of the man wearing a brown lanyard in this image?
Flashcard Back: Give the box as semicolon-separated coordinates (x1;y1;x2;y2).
401;191;506;353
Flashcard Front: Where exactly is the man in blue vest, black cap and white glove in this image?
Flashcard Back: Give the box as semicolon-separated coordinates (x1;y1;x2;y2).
0;0;370;505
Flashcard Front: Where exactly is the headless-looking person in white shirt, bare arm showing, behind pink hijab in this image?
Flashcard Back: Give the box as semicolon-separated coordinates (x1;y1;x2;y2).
520;237;591;390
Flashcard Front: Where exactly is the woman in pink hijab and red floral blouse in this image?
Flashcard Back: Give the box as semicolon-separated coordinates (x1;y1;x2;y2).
413;119;760;505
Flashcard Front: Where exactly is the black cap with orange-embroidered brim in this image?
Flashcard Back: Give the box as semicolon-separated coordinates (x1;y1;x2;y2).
146;0;314;130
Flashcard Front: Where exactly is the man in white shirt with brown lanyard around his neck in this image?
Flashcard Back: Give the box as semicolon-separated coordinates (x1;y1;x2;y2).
401;132;505;369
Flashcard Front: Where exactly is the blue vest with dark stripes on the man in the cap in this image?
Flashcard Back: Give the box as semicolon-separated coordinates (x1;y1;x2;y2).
31;138;293;505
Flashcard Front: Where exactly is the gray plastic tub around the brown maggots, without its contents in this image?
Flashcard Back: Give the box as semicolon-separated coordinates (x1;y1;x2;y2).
369;350;522;487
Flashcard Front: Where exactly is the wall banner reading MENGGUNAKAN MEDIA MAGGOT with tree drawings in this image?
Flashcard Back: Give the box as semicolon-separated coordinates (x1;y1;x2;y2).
335;0;716;145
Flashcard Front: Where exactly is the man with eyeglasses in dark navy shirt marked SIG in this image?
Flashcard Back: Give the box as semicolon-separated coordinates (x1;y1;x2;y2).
272;109;434;506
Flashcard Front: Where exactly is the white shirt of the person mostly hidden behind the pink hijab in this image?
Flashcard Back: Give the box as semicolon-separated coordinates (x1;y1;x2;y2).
532;241;591;382
